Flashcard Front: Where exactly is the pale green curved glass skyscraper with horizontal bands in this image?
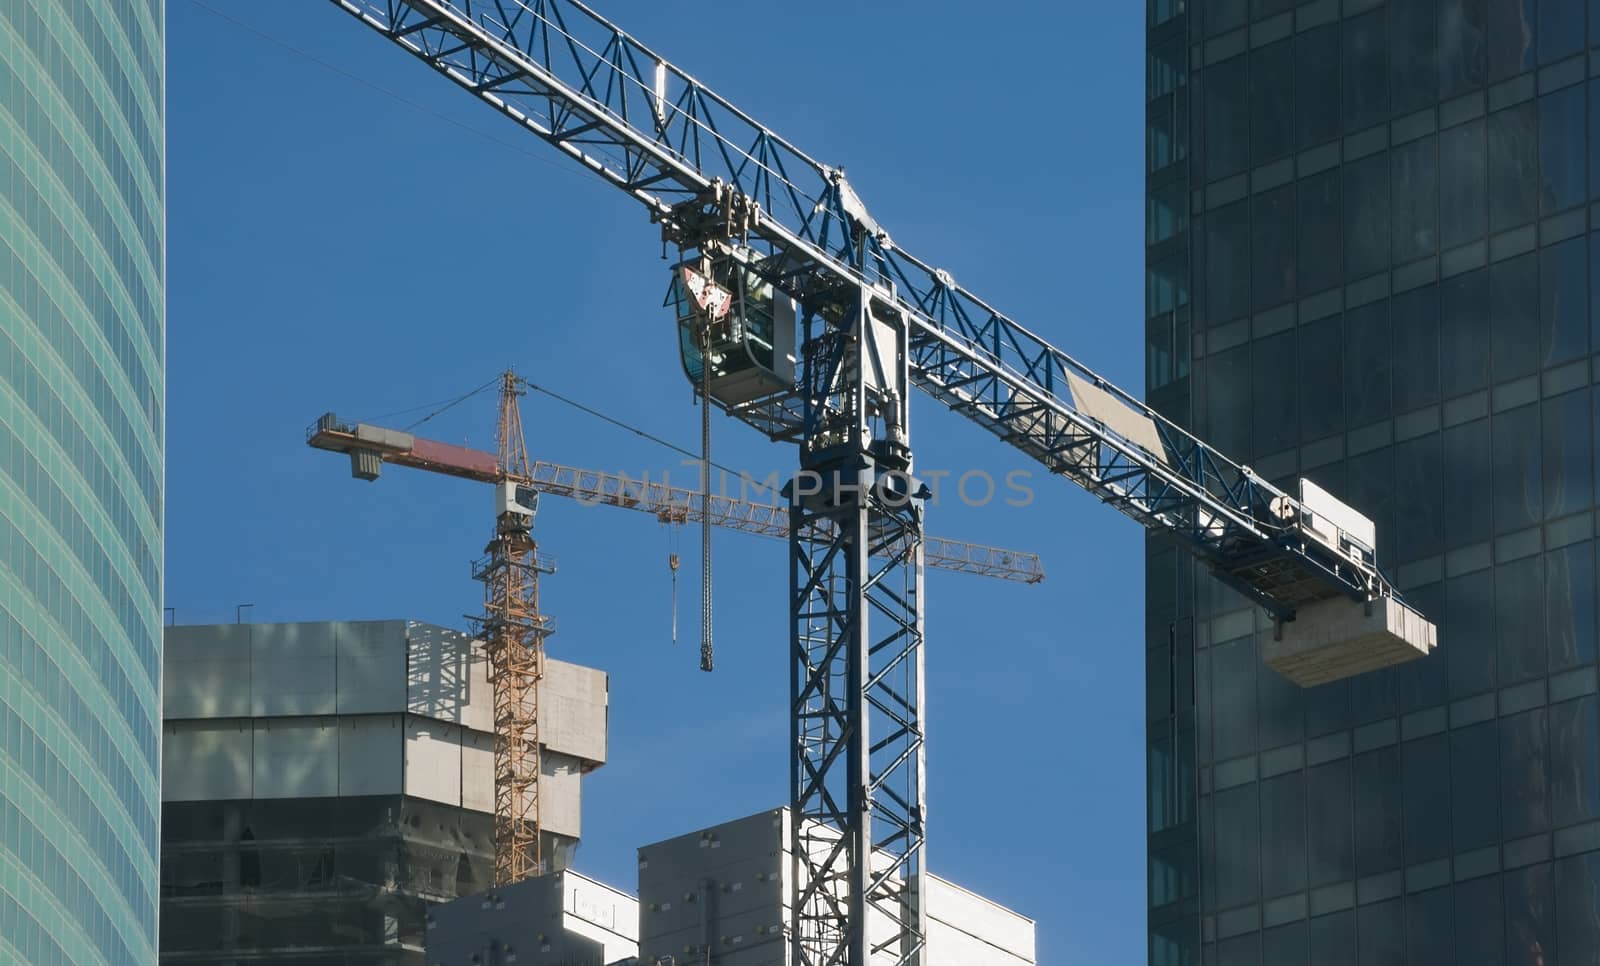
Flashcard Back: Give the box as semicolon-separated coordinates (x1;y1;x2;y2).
0;0;166;964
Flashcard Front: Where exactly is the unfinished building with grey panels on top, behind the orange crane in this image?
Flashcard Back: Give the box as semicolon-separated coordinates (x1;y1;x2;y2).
160;621;608;966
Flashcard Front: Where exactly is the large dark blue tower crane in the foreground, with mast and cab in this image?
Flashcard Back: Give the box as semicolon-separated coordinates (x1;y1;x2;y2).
312;0;1435;966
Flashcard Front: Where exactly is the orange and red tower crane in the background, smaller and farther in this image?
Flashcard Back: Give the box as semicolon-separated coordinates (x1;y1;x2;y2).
306;369;1045;886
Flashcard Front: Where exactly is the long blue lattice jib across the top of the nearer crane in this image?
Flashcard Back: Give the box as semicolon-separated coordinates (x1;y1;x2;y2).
324;0;1440;658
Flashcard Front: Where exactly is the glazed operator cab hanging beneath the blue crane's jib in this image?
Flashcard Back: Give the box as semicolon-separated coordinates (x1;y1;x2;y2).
667;248;795;406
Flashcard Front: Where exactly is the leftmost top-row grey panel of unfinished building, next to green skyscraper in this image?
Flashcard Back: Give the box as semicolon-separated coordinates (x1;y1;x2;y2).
162;624;250;718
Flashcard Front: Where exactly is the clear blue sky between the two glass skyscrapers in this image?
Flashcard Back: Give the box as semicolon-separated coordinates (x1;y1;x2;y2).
166;0;1144;963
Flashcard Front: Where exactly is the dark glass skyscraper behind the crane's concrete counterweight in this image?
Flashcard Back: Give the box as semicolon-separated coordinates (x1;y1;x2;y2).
1146;0;1600;966
